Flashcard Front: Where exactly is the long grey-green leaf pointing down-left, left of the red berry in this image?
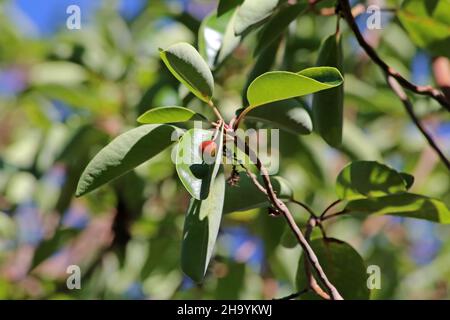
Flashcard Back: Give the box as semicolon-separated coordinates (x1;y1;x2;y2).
75;124;177;197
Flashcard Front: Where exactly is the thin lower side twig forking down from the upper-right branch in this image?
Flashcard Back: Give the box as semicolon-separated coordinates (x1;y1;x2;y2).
387;76;450;170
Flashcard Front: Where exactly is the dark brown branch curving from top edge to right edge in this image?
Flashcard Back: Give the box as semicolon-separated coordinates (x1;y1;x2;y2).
339;0;450;112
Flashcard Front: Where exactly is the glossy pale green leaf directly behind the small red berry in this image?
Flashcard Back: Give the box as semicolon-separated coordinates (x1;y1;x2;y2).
176;126;223;200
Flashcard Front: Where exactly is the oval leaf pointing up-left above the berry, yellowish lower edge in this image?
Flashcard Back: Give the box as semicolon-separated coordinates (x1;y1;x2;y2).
160;42;214;102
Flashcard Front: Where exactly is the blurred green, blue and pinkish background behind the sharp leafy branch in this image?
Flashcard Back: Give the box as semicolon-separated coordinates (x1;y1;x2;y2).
0;0;450;299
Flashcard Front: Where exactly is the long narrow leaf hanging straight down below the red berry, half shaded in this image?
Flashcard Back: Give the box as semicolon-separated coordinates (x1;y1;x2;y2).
181;171;225;282
